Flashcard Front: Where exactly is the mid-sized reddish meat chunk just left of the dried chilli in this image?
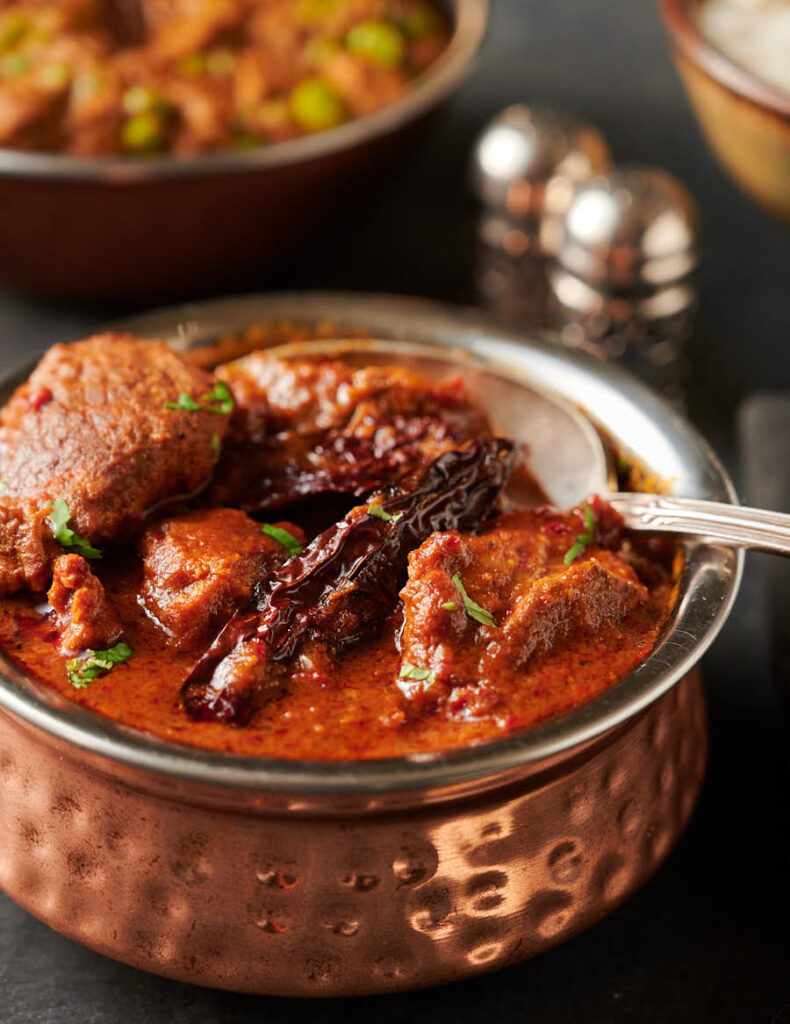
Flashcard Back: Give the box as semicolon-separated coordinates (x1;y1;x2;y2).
140;509;304;647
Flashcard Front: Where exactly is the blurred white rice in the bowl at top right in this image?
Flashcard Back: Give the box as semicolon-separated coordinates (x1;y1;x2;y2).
699;0;790;92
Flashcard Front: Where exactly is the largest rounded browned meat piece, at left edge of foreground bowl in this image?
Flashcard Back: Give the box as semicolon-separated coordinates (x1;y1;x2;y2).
0;334;228;561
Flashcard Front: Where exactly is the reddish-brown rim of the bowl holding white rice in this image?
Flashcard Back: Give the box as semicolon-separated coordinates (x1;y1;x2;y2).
659;0;790;118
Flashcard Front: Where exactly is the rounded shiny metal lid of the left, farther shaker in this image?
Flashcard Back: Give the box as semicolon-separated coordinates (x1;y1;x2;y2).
471;103;611;217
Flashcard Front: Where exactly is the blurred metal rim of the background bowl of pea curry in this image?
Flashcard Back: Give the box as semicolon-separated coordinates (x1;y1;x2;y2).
0;0;489;184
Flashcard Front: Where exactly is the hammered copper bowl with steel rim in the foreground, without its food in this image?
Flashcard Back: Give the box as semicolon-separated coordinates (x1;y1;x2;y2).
0;295;741;996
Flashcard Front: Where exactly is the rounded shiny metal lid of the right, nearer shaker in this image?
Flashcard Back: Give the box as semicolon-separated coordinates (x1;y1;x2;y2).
556;166;699;289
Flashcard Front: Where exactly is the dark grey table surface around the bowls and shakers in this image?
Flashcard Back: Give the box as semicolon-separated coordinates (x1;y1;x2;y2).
0;0;790;1024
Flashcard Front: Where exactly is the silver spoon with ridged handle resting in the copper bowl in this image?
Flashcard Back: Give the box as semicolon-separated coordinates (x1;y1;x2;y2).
261;340;790;555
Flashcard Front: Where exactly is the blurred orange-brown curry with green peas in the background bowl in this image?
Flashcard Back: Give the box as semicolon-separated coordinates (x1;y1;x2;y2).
0;0;449;157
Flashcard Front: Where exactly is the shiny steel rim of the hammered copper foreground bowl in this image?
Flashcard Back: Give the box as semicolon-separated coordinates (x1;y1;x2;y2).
0;293;744;794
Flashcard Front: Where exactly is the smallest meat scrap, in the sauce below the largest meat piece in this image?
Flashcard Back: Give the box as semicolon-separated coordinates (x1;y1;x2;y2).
47;555;123;654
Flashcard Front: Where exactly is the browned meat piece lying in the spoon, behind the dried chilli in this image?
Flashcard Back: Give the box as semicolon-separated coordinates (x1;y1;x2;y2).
211;352;491;511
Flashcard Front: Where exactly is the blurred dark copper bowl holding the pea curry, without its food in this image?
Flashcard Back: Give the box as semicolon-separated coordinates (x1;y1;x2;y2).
0;0;488;302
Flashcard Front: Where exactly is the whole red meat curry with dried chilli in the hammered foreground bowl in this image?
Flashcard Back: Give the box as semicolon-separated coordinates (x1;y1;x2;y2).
0;335;680;760
